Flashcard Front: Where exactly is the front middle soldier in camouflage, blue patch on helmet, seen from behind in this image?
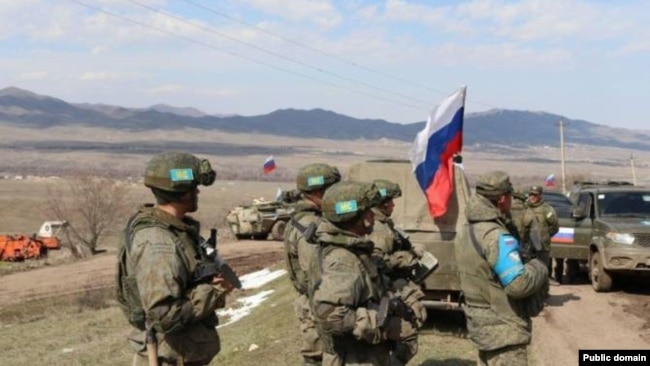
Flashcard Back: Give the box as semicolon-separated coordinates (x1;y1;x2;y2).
309;182;416;366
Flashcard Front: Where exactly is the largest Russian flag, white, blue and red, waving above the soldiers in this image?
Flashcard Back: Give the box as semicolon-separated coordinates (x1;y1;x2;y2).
409;86;467;217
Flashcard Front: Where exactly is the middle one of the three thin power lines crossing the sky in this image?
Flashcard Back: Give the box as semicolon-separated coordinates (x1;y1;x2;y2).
126;0;430;105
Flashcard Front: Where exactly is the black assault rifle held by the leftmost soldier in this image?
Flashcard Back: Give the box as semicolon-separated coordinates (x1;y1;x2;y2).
192;229;242;288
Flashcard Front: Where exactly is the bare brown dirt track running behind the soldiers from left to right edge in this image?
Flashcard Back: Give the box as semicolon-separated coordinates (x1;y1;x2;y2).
0;241;650;366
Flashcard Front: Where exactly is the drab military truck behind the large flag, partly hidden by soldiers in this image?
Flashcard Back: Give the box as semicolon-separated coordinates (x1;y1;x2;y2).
346;160;470;309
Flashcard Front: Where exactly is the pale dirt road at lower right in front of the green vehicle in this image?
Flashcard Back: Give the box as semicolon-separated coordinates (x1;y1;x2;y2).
532;284;650;366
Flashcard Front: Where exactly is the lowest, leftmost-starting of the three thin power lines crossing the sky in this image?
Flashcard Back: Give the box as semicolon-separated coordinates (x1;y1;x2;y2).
70;0;422;110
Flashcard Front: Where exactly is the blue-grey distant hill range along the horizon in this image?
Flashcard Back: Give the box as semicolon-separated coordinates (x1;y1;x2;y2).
0;87;650;150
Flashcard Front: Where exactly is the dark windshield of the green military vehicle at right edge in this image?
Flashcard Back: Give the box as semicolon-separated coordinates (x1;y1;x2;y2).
597;191;650;217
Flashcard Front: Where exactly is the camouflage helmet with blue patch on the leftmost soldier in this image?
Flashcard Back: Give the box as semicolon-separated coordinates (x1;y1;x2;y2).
144;151;217;192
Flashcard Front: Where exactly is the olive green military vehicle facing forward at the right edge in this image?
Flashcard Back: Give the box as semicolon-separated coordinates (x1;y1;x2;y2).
566;182;650;292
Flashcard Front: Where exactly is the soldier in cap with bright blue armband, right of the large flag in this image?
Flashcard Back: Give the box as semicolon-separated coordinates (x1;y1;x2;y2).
455;171;548;365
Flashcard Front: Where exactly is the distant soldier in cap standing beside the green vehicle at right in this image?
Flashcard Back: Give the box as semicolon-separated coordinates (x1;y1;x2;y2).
523;186;560;282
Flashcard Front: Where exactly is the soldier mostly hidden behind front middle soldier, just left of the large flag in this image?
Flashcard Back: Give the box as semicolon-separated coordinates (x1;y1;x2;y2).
369;179;427;366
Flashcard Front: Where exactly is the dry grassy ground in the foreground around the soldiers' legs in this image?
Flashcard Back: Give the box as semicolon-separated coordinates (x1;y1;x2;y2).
0;264;475;366
